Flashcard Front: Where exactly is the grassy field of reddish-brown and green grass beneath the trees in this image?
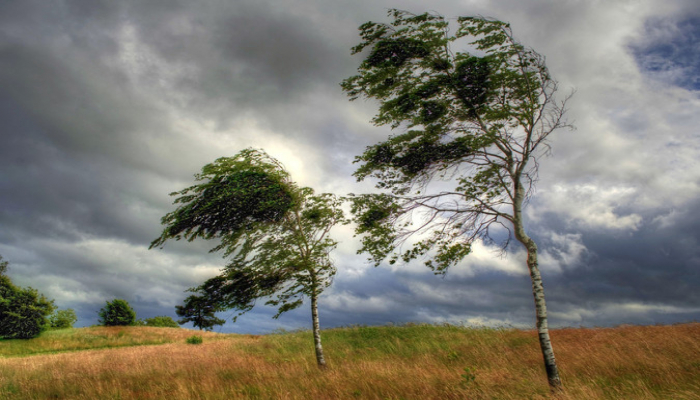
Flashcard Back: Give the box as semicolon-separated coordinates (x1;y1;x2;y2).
0;323;700;400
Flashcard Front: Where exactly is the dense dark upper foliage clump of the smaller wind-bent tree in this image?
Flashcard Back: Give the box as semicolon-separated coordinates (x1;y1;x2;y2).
150;149;295;251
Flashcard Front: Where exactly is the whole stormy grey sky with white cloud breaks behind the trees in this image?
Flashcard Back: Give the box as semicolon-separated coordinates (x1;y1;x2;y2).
0;0;700;333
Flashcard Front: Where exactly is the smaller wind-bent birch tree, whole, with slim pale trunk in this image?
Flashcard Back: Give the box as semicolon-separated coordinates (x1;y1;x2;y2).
151;149;347;367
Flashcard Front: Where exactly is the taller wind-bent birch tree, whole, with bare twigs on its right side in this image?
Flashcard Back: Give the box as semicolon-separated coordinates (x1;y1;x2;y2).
342;10;568;389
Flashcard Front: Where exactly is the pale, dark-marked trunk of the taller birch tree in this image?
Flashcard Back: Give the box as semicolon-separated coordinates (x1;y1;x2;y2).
513;185;562;391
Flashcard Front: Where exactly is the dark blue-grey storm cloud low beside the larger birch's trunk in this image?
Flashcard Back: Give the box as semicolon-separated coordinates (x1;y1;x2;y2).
533;197;700;325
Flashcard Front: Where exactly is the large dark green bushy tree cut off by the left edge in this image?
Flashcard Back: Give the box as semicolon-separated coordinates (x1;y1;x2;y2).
0;256;55;339
